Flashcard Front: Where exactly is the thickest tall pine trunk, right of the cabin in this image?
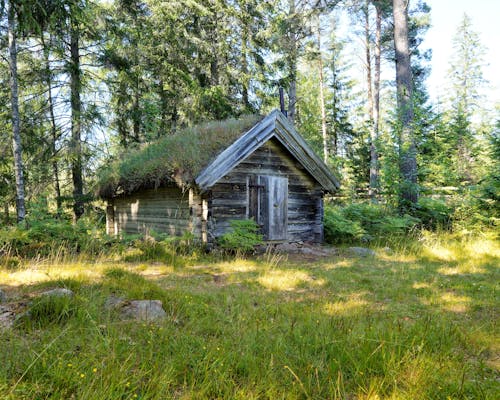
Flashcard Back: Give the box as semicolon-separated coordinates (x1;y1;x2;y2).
393;0;418;210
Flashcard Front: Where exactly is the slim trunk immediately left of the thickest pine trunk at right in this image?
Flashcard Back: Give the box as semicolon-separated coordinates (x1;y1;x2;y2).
370;2;382;203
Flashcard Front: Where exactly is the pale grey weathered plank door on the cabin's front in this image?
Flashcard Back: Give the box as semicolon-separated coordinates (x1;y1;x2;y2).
258;175;288;240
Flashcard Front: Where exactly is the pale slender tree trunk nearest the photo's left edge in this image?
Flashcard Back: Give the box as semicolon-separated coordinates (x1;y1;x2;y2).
7;0;26;222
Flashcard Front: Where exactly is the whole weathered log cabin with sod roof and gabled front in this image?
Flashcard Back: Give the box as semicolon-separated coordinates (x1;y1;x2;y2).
100;110;339;244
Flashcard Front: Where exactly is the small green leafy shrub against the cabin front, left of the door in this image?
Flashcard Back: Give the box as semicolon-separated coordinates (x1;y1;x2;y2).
218;219;263;254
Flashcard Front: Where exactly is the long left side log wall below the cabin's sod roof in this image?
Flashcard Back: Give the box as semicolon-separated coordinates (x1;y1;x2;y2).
107;187;201;236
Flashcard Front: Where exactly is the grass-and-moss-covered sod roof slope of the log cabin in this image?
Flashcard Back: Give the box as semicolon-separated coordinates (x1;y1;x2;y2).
97;115;262;198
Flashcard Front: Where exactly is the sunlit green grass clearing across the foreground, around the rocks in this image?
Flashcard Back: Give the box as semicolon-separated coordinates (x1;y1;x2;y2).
0;235;500;399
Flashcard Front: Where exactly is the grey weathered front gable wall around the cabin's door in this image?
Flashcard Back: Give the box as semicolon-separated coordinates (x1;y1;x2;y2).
205;139;323;242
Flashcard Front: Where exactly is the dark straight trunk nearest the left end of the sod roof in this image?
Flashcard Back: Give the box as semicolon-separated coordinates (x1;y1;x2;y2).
70;20;84;221
